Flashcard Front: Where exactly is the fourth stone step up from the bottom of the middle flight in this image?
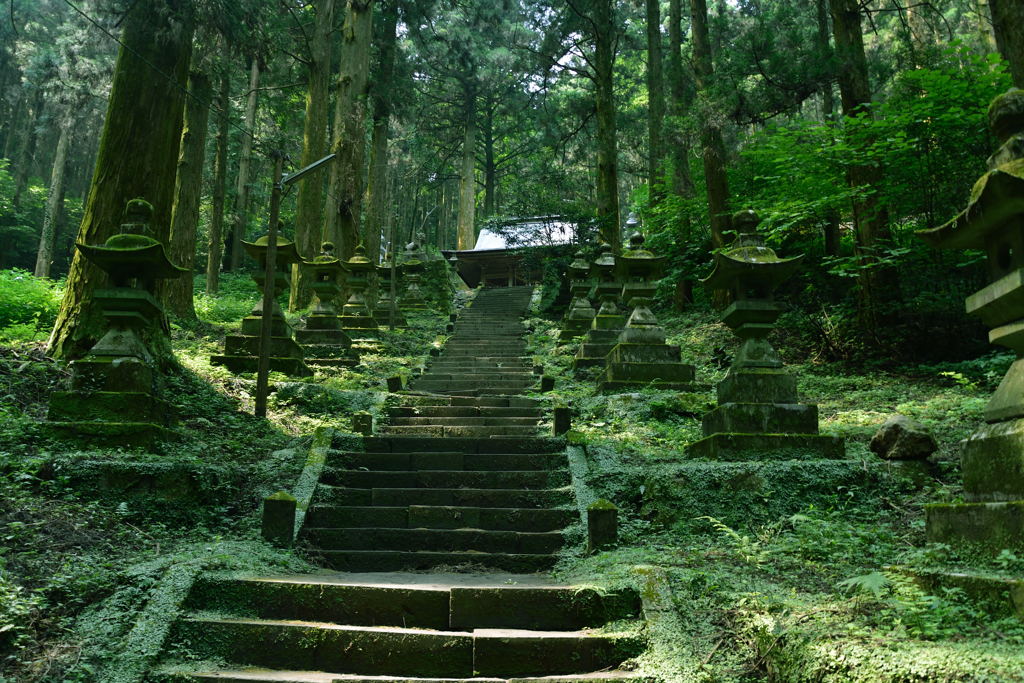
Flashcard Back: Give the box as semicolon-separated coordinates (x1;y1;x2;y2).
313;483;572;508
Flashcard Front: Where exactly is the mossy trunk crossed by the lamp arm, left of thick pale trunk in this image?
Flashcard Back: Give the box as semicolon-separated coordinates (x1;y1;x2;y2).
288;0;335;310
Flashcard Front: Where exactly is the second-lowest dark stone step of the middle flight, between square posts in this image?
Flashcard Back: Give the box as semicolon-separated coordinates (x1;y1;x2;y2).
302;526;565;555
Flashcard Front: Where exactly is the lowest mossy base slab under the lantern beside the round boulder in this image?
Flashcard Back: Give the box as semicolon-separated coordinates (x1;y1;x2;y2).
686;433;846;461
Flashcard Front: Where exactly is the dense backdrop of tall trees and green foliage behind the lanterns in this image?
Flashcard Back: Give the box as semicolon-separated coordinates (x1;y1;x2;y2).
0;0;1021;359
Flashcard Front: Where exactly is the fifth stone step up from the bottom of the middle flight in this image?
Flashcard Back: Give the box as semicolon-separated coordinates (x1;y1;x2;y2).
321;467;569;489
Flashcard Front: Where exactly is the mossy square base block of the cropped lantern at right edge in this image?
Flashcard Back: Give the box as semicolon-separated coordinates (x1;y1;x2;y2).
925;501;1024;554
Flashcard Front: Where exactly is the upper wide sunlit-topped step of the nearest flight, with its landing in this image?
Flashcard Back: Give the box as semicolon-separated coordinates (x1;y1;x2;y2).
183;573;640;631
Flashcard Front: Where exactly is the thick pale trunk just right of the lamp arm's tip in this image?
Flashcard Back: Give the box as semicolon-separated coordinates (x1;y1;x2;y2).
326;0;376;259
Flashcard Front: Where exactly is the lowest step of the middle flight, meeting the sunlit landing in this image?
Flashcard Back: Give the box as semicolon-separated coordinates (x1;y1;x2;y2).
319;550;558;573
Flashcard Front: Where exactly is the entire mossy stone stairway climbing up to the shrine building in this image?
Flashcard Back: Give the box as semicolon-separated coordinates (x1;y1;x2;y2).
154;288;648;683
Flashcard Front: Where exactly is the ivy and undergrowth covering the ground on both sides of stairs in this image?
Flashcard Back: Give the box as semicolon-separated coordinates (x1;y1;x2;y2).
0;270;1024;683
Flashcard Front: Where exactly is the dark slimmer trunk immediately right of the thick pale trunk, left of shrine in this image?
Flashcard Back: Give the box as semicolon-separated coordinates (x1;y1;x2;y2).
365;0;398;262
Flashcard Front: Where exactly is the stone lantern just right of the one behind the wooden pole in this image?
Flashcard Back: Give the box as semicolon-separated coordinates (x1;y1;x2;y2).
295;242;358;367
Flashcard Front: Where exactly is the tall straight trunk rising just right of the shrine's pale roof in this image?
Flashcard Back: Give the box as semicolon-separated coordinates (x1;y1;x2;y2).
592;0;623;254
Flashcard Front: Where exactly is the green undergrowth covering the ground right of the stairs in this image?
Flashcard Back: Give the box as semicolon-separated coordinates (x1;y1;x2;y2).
529;308;1024;681
